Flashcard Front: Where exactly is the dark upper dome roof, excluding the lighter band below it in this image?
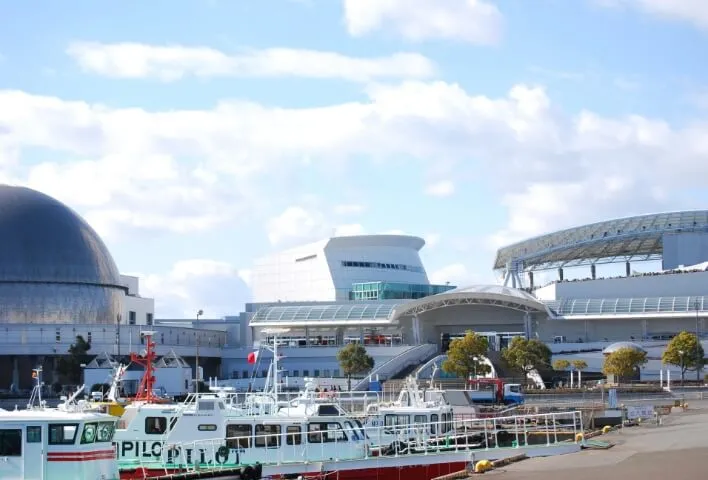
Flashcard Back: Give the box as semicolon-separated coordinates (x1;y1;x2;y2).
0;185;120;286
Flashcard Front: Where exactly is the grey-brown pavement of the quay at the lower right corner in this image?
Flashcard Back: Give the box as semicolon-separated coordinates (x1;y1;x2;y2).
486;401;708;480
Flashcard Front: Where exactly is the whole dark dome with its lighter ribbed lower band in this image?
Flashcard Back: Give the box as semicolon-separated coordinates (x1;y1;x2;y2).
0;185;128;324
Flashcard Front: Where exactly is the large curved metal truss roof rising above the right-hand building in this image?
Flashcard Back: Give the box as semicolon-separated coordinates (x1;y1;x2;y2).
494;210;708;271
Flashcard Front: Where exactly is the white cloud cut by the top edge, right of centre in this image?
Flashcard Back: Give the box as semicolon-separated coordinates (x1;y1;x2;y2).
344;0;504;45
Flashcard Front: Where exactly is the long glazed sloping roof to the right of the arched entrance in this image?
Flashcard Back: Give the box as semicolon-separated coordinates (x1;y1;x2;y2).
544;297;708;317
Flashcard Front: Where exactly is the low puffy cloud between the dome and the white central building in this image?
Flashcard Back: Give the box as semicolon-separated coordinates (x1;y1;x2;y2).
140;259;250;318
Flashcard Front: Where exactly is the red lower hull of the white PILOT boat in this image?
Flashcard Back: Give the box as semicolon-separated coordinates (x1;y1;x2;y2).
120;462;467;480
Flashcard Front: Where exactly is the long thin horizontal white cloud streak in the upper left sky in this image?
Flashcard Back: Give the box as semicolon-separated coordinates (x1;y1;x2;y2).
67;42;436;82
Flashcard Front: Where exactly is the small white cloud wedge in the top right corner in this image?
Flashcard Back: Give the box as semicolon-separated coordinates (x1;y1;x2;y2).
594;0;708;29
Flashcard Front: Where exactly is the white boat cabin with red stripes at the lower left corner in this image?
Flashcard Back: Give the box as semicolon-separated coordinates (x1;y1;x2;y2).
0;368;119;480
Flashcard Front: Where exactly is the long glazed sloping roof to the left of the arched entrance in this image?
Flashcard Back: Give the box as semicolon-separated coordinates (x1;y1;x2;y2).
250;302;397;327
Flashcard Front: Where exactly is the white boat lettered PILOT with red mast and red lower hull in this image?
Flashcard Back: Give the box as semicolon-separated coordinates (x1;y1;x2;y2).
114;332;582;480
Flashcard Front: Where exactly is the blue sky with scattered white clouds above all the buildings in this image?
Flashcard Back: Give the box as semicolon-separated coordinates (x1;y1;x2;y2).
0;0;708;318
